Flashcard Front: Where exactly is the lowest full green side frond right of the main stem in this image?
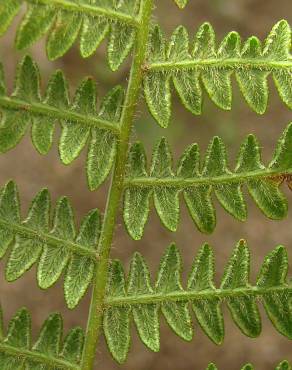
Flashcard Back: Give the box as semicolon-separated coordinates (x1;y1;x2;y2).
104;240;292;363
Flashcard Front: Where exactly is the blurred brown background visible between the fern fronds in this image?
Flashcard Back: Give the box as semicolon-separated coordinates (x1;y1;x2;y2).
0;0;292;370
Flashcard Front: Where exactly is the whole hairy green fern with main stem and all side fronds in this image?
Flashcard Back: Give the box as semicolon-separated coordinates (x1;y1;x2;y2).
0;0;292;370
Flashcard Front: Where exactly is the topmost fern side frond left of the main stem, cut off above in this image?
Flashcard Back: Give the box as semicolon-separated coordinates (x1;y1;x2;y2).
0;0;140;70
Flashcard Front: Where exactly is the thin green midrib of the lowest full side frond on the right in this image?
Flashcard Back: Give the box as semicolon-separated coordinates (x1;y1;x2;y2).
105;285;292;307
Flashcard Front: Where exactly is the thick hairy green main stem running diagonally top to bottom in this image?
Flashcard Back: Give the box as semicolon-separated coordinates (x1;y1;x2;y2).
81;0;153;370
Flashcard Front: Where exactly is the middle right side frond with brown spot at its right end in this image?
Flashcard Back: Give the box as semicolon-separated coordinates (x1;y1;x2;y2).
124;123;292;240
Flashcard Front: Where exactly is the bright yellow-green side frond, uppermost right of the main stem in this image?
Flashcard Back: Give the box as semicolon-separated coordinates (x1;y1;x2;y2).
144;20;292;127
